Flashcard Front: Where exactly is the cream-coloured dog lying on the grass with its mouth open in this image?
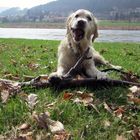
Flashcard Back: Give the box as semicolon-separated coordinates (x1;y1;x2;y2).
50;9;120;79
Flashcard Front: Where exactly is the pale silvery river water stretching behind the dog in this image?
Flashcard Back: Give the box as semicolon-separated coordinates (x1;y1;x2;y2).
0;28;140;42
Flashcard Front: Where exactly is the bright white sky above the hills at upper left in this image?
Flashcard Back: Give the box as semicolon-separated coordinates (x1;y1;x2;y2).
0;0;54;8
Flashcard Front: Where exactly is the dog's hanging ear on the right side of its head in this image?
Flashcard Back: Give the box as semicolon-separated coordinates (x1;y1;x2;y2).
92;17;98;42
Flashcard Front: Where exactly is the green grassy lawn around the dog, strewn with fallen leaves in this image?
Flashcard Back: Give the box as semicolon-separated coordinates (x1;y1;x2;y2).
0;39;140;140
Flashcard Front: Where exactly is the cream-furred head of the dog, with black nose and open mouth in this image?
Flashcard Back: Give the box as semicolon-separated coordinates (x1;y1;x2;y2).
66;9;98;43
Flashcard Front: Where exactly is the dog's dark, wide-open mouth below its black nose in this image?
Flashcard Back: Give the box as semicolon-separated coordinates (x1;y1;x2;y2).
71;28;85;42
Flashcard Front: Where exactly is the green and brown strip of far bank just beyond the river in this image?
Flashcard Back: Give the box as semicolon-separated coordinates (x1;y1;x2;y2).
0;20;140;30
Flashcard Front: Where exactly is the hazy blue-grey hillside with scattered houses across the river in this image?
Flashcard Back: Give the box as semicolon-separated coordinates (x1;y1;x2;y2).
0;0;140;22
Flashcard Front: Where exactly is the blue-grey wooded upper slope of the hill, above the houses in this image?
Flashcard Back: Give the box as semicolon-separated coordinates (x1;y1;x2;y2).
29;0;140;13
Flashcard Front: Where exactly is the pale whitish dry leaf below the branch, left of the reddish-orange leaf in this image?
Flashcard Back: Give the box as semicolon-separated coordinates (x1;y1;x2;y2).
27;94;38;109
